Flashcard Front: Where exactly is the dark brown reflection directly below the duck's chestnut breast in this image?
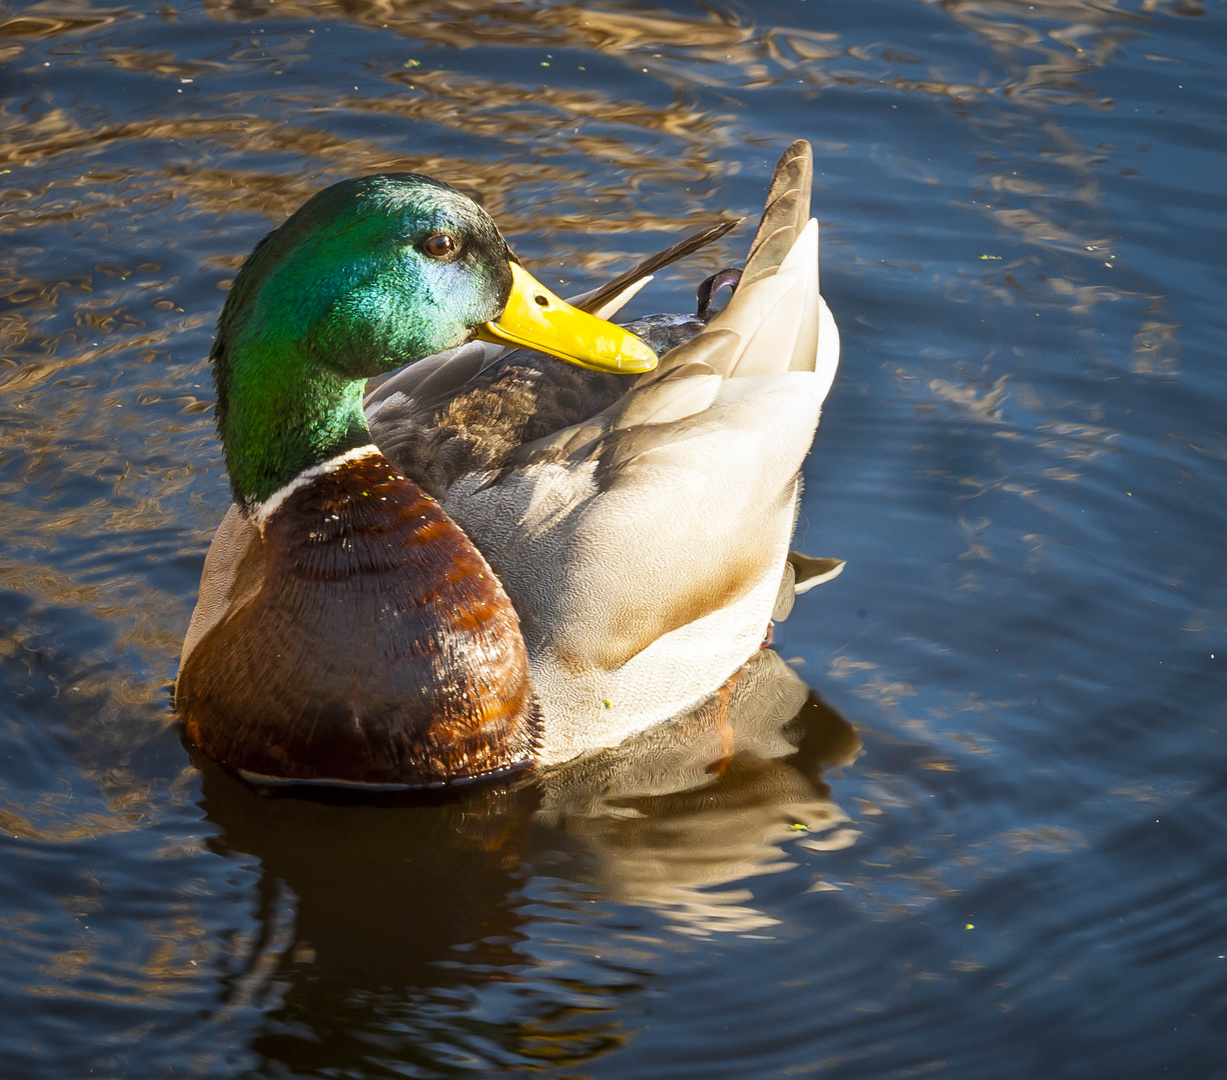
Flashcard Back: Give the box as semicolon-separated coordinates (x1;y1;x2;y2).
198;756;531;1073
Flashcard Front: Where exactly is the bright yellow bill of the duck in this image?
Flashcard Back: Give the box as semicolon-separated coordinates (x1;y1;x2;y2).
477;263;656;374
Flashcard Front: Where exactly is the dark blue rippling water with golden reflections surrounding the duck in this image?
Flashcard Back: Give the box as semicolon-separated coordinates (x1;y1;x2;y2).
0;0;1227;1080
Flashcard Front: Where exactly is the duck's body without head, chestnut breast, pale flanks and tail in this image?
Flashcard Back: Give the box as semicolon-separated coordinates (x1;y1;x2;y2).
175;144;838;785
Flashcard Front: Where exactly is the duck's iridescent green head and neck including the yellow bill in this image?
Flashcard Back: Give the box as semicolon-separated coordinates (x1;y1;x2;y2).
212;173;655;509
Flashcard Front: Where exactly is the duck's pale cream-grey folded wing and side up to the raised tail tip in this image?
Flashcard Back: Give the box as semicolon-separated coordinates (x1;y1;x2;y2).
440;142;839;763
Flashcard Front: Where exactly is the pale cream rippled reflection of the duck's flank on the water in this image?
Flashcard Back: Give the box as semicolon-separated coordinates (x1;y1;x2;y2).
537;650;860;935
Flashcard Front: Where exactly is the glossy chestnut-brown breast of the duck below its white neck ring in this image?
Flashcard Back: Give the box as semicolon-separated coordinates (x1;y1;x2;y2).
175;454;539;785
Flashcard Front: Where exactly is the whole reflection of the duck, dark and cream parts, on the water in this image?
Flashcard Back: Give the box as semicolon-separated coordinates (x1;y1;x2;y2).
196;649;860;1071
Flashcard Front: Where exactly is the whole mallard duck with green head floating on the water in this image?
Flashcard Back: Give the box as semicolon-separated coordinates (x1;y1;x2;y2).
175;142;842;787
